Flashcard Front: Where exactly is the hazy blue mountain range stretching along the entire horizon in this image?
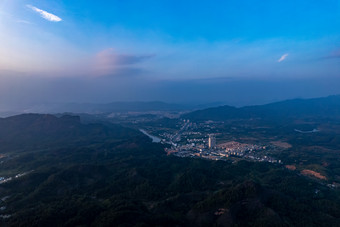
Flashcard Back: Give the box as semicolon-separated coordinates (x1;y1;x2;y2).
0;95;340;121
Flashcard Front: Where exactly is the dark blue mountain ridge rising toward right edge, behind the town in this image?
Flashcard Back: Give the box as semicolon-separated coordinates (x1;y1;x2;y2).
182;95;340;121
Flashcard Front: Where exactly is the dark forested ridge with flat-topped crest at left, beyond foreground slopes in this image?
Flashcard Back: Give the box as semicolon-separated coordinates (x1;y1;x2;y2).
0;114;142;149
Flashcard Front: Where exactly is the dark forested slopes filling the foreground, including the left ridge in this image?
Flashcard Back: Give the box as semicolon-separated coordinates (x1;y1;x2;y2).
0;115;340;226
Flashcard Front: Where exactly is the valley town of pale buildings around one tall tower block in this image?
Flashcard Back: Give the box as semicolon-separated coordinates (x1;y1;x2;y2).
141;120;281;163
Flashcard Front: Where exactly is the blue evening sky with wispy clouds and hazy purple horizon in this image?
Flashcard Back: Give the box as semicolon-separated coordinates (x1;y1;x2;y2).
0;0;340;109
